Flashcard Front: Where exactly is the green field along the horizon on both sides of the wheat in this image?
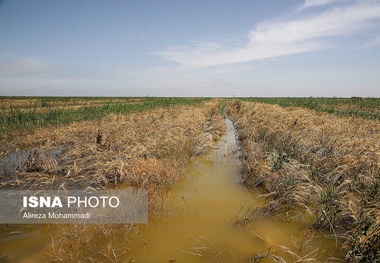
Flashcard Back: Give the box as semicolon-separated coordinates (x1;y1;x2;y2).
0;97;380;133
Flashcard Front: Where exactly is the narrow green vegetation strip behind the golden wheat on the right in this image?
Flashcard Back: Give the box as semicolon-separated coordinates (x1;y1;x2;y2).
245;97;380;120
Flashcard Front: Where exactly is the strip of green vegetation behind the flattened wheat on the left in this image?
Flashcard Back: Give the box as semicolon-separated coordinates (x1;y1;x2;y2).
0;97;205;133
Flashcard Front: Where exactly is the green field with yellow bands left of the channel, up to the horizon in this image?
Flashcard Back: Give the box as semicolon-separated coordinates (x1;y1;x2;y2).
0;97;205;133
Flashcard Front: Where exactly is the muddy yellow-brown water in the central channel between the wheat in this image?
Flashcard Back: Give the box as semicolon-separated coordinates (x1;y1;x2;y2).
126;119;343;262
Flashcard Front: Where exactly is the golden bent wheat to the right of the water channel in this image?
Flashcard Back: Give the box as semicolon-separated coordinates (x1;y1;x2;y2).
229;100;380;262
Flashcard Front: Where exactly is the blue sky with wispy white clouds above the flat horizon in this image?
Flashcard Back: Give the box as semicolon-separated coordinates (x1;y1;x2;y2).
0;0;380;97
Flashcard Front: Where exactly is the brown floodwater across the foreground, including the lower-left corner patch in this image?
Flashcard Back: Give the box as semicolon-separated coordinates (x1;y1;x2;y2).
0;119;345;263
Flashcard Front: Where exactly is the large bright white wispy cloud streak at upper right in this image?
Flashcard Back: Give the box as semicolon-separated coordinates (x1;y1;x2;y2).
155;0;380;67
